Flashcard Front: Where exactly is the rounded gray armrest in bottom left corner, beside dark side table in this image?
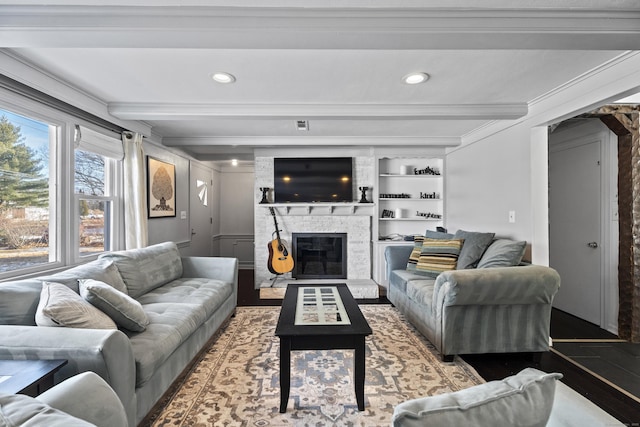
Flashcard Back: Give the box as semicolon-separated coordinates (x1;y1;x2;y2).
37;372;128;427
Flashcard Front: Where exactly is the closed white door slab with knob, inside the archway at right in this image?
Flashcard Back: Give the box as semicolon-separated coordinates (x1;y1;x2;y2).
549;141;602;325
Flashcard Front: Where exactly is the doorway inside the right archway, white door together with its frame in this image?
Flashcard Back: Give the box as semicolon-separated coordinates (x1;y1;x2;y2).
549;120;618;333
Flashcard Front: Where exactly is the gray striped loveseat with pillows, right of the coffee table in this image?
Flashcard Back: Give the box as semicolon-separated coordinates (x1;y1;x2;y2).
385;231;560;361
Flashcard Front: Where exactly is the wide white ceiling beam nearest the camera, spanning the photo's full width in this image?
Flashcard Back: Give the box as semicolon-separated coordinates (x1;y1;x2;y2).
0;3;640;50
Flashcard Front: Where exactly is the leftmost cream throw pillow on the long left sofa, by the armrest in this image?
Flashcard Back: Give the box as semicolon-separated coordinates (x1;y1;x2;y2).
36;282;116;329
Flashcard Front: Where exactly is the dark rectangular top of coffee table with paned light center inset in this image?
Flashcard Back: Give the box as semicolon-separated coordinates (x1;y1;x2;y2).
276;283;372;337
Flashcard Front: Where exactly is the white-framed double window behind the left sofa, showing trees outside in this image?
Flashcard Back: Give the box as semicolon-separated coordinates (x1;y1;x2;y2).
0;101;123;279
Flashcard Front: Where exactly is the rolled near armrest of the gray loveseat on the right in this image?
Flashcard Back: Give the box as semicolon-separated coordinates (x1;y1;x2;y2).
433;265;560;306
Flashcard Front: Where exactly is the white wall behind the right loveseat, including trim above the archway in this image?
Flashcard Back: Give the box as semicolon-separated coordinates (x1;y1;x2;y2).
445;52;640;265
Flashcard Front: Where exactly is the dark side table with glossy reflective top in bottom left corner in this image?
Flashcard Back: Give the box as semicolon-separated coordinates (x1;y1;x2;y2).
0;359;67;397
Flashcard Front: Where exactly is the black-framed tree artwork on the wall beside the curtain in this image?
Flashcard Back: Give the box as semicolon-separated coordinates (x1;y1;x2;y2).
147;156;176;218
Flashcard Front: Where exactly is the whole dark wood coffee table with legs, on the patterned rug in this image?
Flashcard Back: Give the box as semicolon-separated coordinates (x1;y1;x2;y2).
276;283;372;413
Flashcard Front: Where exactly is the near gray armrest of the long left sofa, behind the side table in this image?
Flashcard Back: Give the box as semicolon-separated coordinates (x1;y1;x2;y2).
0;325;136;426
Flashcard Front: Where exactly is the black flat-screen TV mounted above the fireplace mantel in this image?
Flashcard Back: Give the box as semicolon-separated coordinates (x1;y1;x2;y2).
273;157;353;203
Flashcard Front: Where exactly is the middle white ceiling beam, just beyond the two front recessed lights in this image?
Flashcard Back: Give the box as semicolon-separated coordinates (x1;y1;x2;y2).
109;103;528;120
